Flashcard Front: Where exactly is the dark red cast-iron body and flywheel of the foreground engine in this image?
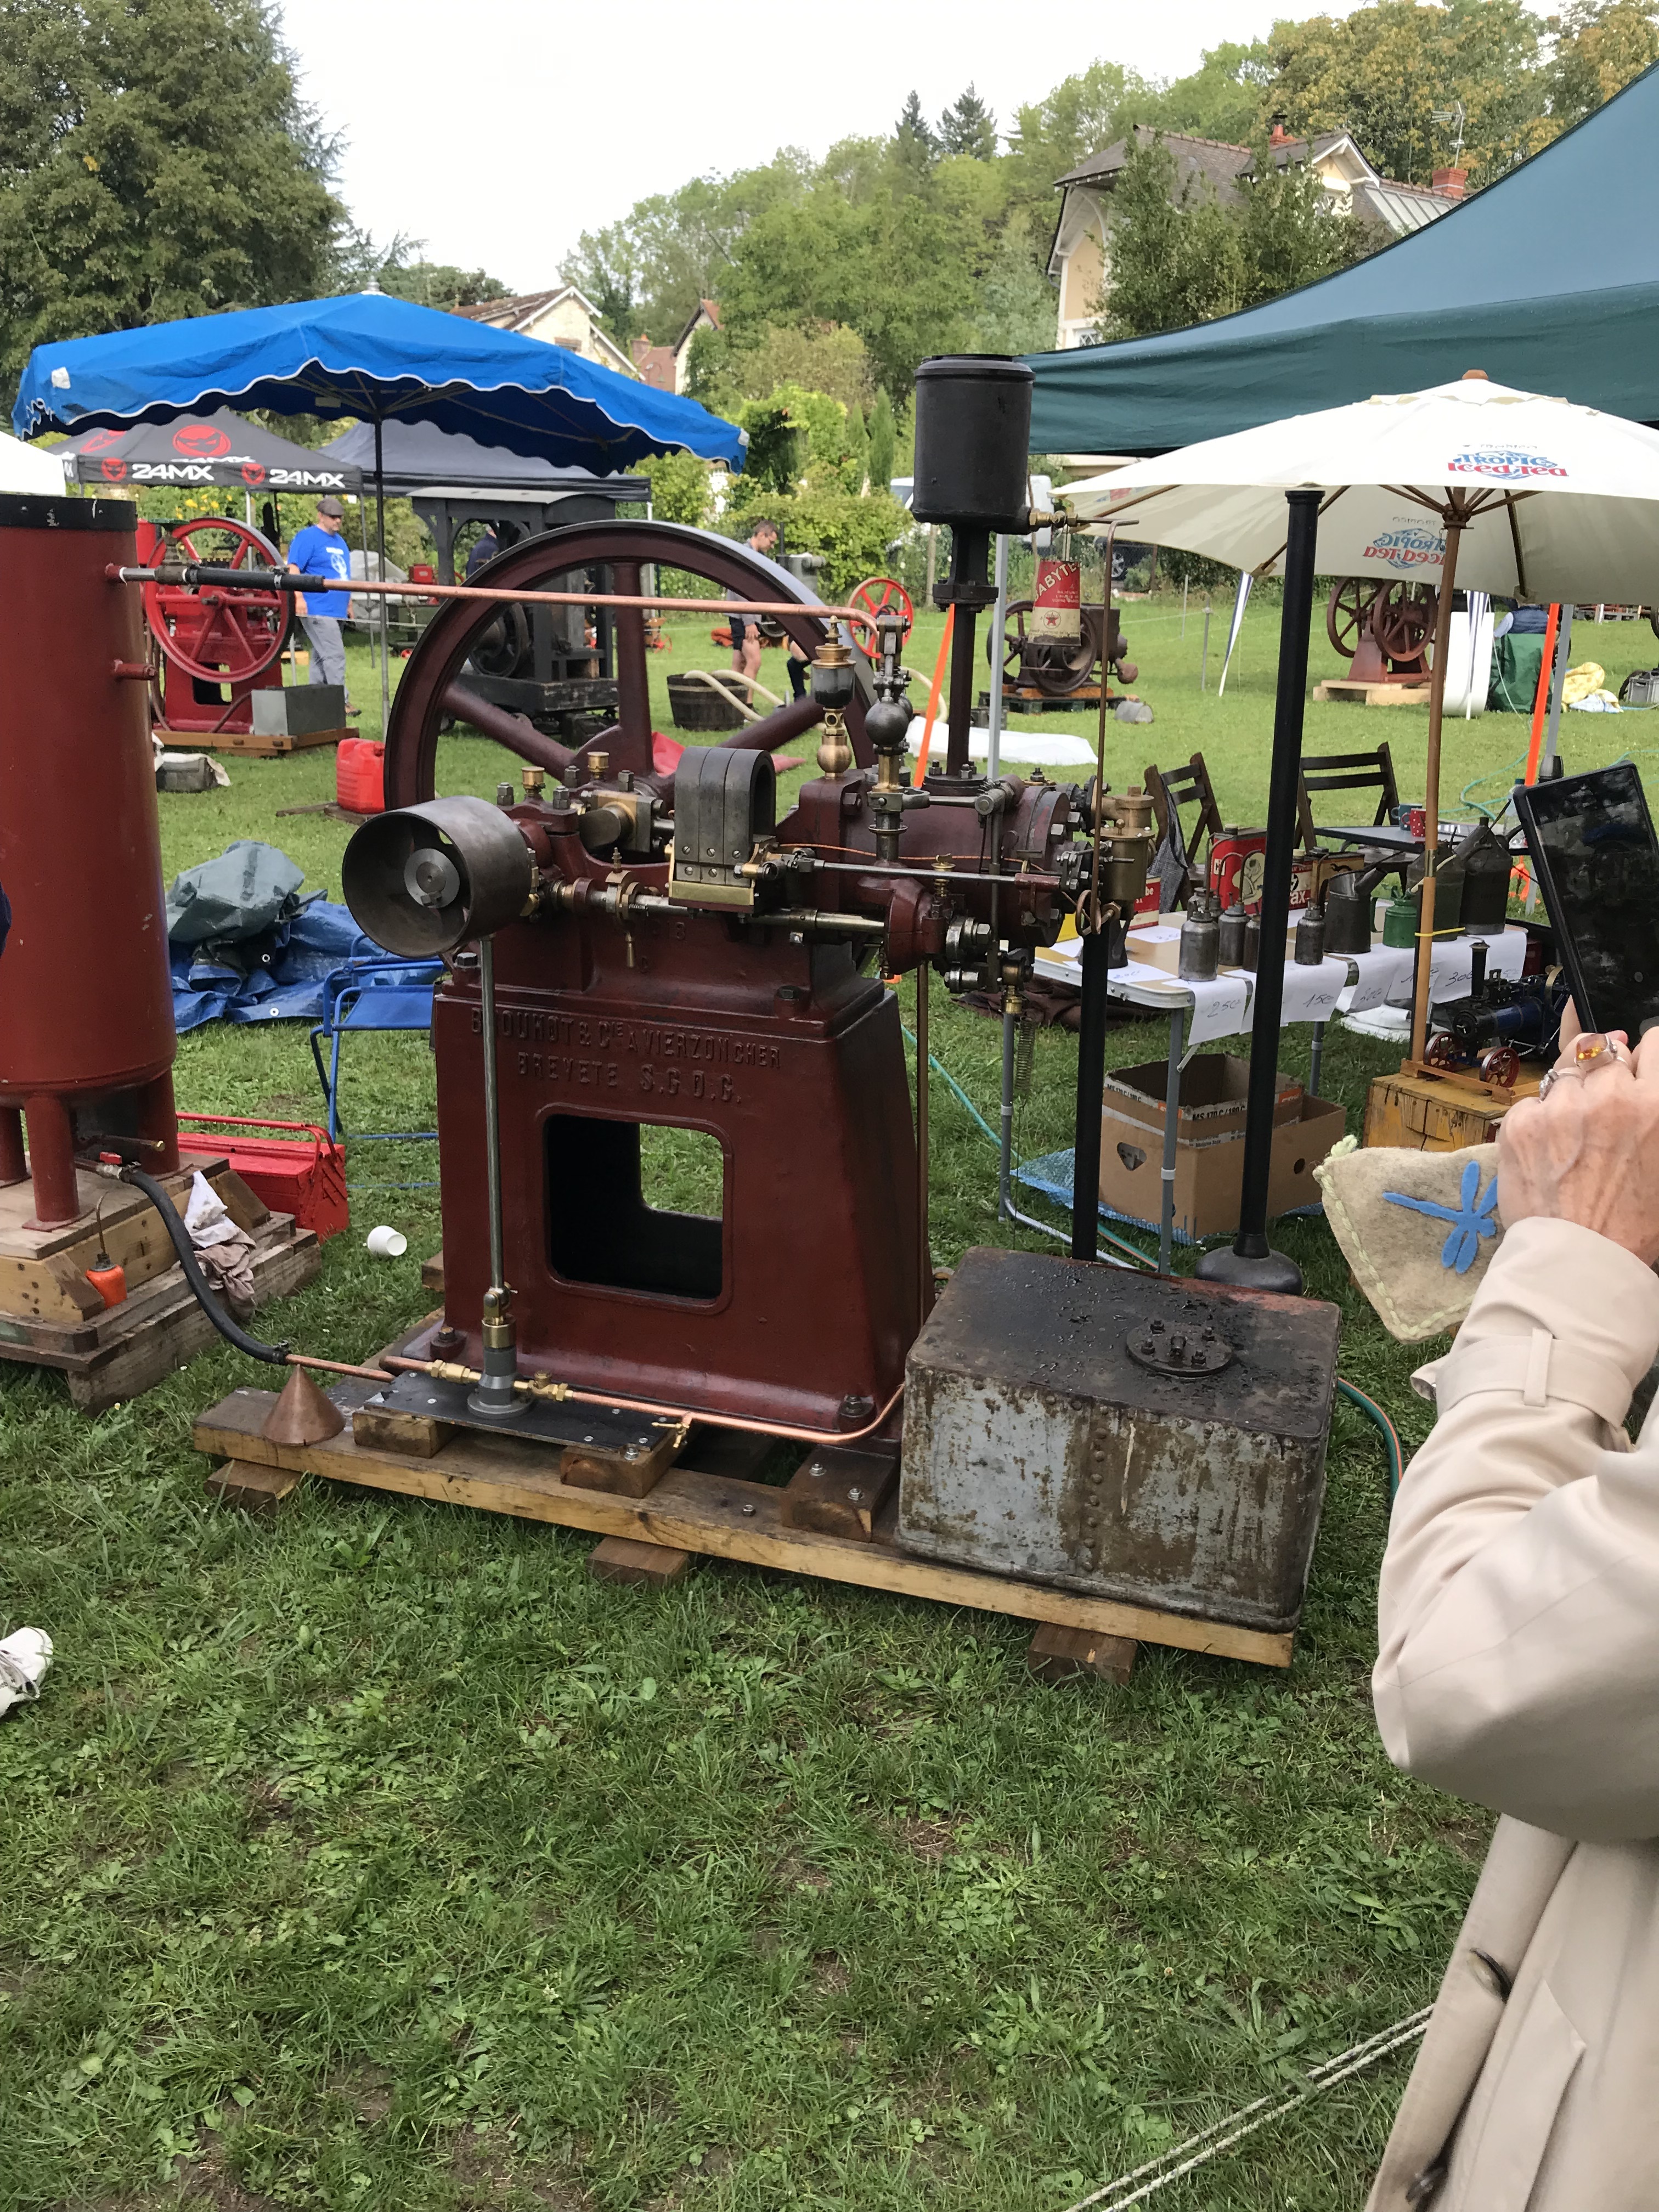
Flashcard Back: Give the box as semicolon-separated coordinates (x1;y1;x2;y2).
376;522;1106;1431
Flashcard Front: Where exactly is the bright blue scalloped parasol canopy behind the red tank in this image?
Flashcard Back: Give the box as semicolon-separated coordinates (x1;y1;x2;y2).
11;292;746;473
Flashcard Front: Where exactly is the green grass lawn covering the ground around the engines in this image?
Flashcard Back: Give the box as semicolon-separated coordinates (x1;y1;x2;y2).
0;602;1657;2212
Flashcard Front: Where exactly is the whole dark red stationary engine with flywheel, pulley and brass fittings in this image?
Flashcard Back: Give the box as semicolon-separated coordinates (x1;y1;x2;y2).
343;509;1150;1438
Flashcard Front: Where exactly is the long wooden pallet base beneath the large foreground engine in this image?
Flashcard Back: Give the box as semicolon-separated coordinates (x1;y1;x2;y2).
190;1380;1294;1679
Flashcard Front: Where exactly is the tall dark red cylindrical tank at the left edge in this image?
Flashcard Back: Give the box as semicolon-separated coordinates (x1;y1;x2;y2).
0;495;179;1228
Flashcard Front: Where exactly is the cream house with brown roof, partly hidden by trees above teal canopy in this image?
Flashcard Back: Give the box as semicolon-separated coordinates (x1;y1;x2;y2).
1048;124;1469;352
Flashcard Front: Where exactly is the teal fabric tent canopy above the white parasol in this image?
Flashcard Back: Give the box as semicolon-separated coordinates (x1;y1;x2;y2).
1026;69;1659;454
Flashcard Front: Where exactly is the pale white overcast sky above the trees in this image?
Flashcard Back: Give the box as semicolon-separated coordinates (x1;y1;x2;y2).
283;0;1352;292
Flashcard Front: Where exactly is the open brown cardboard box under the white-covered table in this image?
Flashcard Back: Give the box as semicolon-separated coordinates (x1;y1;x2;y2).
1099;1084;1347;1239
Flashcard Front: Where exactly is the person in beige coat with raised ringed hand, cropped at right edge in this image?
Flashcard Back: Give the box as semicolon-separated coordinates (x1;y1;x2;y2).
1367;1024;1659;2212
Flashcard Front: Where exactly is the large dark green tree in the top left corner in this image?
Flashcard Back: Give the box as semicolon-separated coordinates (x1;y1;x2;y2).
0;0;345;378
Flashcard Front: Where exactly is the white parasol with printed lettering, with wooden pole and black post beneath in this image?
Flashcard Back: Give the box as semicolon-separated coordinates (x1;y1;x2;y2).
1059;369;1659;1290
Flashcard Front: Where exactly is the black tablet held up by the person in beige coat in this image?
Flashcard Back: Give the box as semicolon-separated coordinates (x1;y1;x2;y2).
1515;761;1659;1044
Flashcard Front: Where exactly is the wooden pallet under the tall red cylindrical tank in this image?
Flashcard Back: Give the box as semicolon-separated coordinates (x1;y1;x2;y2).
0;1186;323;1413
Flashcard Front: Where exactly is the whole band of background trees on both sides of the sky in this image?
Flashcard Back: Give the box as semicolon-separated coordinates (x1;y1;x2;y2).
0;0;1659;404
